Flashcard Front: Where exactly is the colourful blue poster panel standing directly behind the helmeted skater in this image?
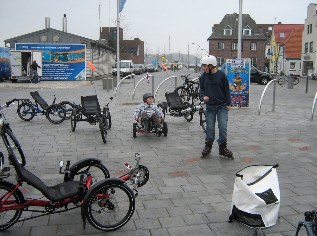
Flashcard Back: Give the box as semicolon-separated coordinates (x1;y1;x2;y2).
226;59;251;108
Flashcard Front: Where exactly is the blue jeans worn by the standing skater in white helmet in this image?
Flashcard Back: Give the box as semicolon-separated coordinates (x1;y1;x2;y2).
205;104;228;144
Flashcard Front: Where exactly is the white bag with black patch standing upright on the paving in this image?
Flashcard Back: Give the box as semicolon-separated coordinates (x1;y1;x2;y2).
229;164;280;228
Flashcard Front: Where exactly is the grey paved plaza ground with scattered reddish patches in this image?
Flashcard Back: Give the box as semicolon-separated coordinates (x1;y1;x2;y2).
0;70;317;236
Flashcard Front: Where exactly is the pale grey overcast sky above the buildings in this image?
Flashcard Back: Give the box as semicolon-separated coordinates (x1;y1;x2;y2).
0;0;317;55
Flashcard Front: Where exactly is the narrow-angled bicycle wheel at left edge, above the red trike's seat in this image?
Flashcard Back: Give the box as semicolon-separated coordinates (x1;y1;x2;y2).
1;129;26;166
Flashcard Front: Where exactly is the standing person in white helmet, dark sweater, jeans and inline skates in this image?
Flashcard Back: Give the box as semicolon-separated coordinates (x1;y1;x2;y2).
199;55;233;159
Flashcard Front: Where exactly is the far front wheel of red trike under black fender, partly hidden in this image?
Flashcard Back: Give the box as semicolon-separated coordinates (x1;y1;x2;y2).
69;162;110;185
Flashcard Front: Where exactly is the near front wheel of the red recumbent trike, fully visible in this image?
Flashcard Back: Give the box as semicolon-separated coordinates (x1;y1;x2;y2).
82;179;135;231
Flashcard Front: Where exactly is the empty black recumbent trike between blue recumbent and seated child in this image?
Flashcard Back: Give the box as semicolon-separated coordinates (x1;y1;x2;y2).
70;95;113;143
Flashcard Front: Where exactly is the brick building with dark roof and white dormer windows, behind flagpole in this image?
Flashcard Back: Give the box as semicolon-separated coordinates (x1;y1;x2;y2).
208;13;272;71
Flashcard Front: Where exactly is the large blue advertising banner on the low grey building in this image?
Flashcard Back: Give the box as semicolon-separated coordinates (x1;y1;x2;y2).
15;43;86;80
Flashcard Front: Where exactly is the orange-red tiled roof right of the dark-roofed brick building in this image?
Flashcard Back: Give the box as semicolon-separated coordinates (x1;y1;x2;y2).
273;24;304;59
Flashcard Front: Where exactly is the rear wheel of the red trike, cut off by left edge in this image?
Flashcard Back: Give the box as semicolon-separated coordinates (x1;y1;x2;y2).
0;181;25;231
